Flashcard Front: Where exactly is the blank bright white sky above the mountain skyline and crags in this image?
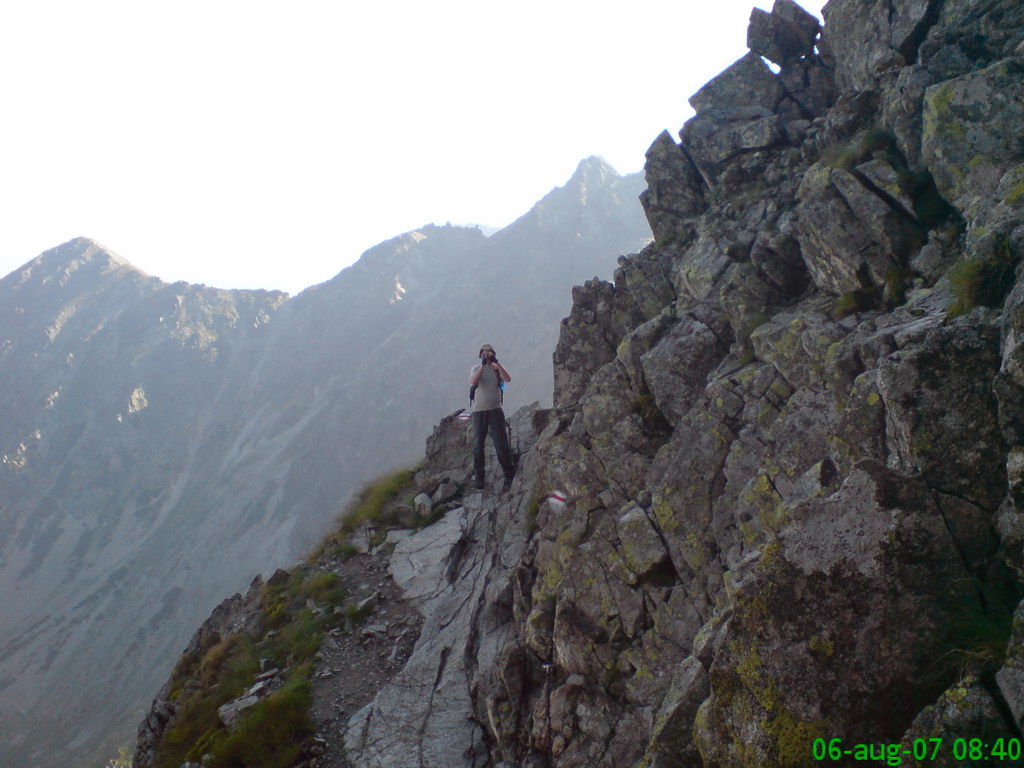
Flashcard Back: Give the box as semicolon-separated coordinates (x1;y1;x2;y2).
0;0;823;293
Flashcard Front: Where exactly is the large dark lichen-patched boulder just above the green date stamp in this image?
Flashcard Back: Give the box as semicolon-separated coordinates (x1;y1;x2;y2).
695;461;977;768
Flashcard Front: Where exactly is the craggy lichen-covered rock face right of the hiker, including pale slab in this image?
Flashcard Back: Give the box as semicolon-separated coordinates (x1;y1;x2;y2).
136;0;1024;768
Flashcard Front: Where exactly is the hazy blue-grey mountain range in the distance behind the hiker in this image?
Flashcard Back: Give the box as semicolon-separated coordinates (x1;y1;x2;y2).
0;158;649;768
